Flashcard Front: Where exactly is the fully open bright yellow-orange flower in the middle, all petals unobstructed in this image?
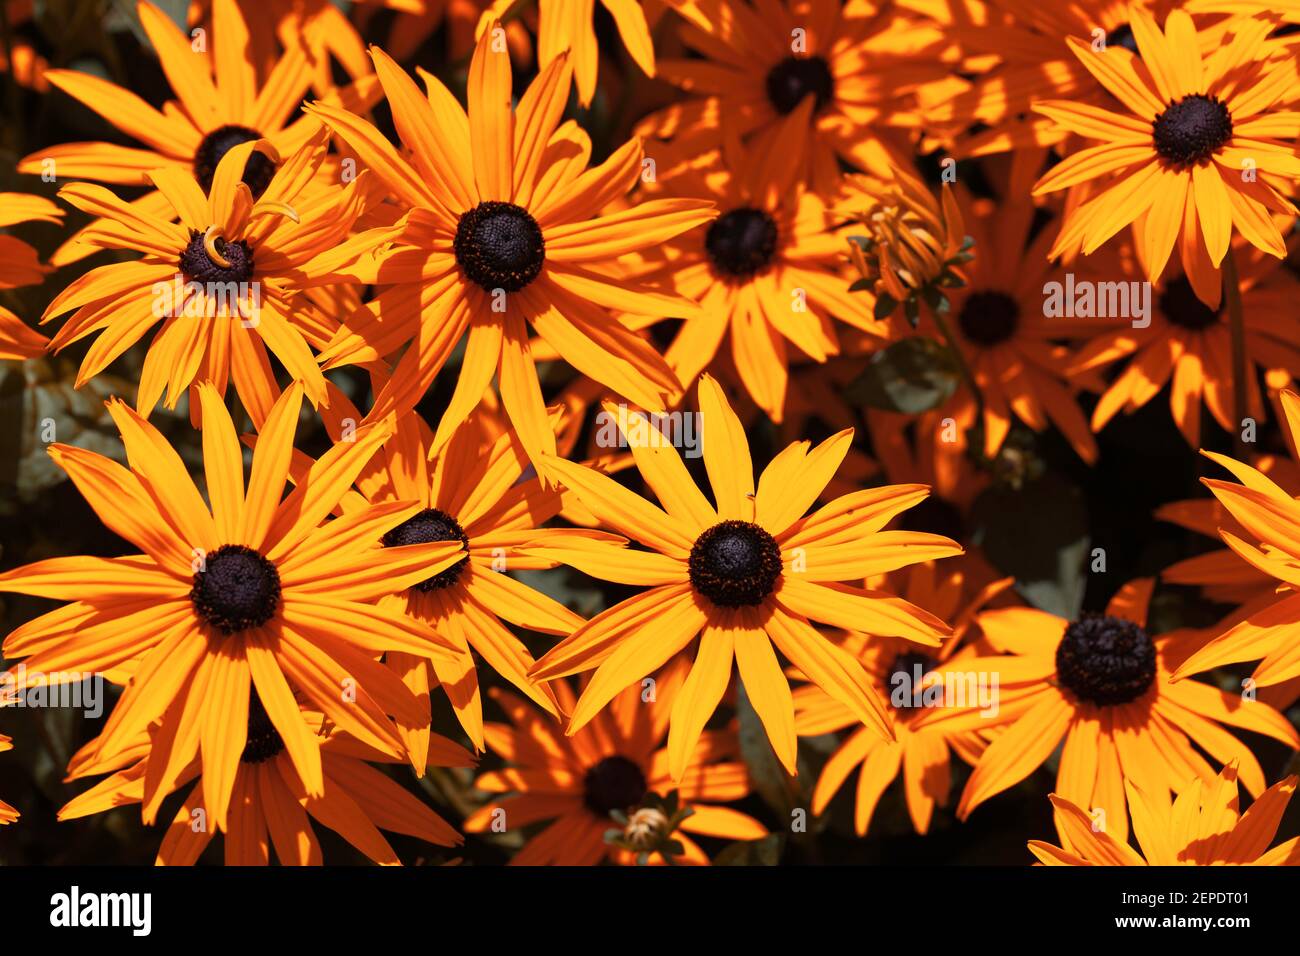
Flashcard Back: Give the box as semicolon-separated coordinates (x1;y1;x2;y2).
529;375;961;779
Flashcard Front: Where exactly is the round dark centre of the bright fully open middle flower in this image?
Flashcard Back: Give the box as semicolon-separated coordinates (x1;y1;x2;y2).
688;520;781;607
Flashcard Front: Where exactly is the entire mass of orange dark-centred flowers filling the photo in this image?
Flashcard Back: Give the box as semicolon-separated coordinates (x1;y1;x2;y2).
0;0;1300;865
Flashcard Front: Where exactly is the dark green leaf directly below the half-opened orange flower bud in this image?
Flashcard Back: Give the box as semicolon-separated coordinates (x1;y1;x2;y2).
845;336;961;415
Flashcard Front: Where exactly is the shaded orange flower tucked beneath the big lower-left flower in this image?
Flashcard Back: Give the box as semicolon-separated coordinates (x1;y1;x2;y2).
59;691;473;866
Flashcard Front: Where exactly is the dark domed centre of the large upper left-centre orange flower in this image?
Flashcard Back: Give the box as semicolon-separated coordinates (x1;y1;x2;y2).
451;202;546;293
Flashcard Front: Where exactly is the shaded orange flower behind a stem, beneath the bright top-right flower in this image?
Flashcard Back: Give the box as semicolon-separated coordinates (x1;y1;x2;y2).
1069;241;1300;447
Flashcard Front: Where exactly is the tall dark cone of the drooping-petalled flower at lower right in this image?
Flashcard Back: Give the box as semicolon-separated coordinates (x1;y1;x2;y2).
1056;614;1156;706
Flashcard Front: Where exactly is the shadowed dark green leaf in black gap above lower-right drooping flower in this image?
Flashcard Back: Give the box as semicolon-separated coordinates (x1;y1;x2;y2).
971;472;1091;619
